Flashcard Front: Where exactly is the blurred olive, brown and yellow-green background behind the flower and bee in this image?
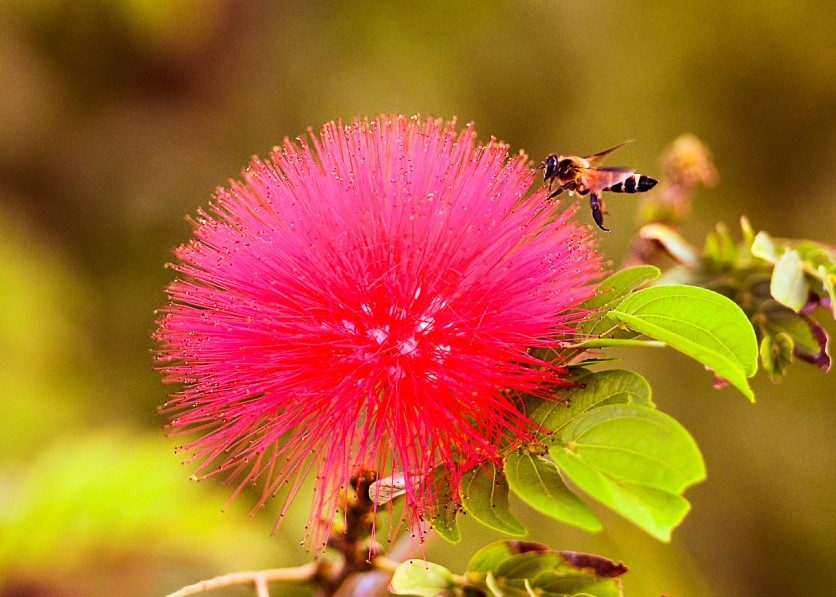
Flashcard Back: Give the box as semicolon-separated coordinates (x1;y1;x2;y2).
0;0;836;597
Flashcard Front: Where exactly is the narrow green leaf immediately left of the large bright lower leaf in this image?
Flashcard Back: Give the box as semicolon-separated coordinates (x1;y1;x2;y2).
505;452;602;531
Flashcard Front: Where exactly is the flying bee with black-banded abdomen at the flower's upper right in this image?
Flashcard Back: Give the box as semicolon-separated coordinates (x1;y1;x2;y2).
537;141;659;230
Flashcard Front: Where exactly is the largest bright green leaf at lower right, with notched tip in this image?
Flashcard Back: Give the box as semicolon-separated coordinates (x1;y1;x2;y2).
549;404;705;541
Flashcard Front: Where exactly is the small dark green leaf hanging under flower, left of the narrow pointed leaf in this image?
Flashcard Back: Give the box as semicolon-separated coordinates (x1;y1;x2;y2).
461;464;528;537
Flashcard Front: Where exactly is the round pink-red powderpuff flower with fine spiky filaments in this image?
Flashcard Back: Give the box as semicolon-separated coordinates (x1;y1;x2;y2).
155;115;601;547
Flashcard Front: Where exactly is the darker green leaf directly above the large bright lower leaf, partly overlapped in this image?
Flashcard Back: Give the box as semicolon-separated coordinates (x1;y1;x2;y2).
526;369;653;432
